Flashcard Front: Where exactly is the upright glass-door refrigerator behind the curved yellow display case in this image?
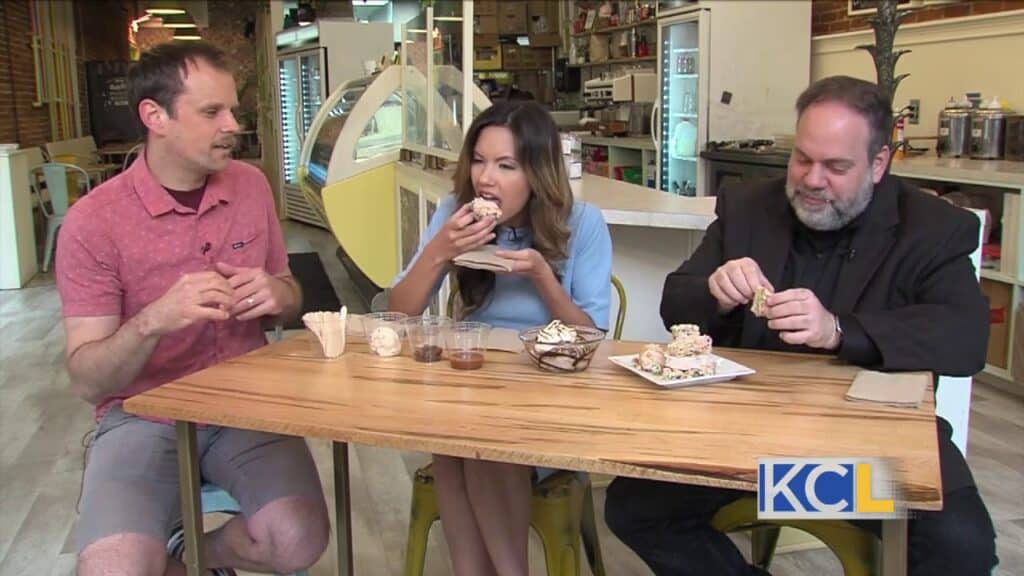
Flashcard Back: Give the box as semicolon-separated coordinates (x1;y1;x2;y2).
276;19;392;228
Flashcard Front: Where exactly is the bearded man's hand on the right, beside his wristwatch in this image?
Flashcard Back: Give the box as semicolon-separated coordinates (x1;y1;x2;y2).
765;288;842;349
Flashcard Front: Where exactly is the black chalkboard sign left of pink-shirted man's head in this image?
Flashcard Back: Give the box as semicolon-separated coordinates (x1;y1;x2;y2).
85;60;142;147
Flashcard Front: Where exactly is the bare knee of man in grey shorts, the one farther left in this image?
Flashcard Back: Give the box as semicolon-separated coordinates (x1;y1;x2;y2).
76;534;167;576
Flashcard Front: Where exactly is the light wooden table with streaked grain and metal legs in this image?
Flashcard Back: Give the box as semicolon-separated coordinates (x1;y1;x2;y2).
125;334;942;575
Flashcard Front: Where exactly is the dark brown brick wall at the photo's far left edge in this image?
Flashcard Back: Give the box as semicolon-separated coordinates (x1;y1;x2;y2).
0;0;50;148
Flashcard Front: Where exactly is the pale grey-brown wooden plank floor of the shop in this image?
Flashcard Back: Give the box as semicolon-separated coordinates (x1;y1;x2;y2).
0;223;1024;576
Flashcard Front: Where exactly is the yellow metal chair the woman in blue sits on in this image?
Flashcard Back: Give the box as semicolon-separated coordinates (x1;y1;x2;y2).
403;276;626;576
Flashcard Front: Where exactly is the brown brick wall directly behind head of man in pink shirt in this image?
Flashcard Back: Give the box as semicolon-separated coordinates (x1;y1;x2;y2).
136;0;261;127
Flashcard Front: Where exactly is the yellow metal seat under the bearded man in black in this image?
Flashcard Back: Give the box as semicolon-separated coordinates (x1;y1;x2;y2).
711;496;879;576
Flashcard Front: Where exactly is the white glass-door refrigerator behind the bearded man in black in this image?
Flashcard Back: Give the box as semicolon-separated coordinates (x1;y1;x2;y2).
651;0;811;196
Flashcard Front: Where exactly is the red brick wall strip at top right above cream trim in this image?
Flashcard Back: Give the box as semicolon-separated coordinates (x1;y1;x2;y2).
811;0;1024;36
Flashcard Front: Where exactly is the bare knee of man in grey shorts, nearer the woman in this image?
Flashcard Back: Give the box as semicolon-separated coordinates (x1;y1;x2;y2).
253;497;331;574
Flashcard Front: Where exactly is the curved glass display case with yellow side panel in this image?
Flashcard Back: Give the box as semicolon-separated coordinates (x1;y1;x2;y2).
297;66;489;287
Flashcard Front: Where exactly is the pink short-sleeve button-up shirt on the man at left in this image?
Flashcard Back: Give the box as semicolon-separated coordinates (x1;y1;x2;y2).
56;156;290;419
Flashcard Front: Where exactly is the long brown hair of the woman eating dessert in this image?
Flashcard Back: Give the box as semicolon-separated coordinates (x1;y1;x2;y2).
455;101;572;316
